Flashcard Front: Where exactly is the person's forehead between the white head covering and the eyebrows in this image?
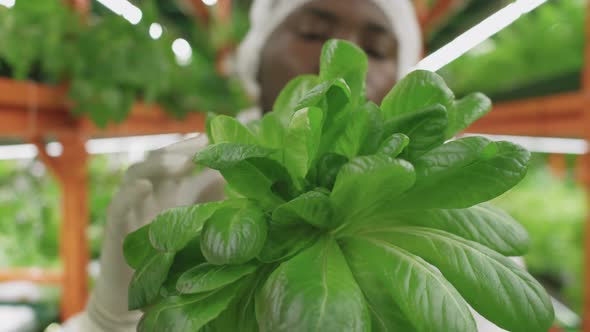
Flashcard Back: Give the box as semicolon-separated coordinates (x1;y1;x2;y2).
296;0;392;32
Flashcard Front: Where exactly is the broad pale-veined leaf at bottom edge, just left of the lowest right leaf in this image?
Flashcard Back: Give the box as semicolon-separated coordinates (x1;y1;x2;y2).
342;237;477;332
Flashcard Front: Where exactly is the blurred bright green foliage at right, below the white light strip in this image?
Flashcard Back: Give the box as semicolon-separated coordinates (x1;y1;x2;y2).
495;155;588;313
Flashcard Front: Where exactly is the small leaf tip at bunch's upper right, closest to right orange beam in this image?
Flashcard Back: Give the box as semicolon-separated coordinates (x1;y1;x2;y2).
445;93;492;139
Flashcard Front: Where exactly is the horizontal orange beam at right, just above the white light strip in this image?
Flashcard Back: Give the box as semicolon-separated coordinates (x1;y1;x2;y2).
467;93;586;138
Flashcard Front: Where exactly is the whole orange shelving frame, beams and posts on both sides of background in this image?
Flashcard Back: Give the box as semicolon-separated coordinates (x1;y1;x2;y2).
0;0;590;326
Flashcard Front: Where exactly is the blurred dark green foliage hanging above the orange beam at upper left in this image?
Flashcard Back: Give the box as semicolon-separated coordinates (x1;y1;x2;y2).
0;0;248;126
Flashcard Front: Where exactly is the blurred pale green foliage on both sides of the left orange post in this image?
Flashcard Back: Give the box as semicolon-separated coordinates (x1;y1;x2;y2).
0;156;124;267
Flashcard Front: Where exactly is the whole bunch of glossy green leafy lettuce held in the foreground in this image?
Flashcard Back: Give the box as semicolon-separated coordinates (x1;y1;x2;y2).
124;40;553;332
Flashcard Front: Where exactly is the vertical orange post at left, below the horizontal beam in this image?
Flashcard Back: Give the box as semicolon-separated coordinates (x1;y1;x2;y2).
57;135;90;320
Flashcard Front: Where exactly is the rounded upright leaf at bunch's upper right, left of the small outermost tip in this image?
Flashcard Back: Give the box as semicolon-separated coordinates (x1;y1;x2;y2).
381;70;455;120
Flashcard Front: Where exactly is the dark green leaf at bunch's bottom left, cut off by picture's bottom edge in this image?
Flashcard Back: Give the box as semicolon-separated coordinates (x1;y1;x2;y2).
137;284;240;332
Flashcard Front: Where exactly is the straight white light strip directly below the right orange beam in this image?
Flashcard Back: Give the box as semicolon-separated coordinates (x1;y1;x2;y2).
462;134;590;155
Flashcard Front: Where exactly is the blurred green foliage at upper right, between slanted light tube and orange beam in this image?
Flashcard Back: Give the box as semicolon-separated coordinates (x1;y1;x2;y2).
440;0;585;99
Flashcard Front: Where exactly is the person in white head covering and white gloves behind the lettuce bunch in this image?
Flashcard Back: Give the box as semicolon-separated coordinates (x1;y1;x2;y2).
64;0;512;332
